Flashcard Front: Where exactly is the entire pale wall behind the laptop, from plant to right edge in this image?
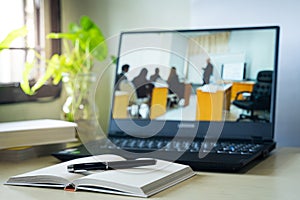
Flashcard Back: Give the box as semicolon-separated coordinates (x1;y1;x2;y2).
62;0;300;146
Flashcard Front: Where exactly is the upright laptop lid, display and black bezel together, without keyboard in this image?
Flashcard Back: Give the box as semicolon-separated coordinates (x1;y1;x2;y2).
109;26;279;144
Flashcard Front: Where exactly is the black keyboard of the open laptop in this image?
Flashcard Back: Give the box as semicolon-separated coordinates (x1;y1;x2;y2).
101;138;263;155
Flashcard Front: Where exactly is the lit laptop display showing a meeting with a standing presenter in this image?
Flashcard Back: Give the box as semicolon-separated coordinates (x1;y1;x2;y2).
112;27;278;123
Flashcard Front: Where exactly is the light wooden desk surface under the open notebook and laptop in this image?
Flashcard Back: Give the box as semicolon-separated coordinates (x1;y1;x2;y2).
0;148;300;200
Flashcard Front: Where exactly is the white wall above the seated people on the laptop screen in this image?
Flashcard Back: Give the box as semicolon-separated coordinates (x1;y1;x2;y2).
118;32;188;80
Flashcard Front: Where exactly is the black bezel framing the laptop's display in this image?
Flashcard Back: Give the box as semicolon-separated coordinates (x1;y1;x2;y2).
108;25;280;140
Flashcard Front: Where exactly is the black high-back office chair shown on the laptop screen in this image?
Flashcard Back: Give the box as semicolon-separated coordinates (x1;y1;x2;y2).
232;70;273;122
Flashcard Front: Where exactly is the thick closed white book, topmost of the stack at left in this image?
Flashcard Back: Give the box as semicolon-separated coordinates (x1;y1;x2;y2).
0;119;77;150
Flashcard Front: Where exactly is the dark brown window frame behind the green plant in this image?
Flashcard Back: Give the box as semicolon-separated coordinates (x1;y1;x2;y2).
0;0;62;104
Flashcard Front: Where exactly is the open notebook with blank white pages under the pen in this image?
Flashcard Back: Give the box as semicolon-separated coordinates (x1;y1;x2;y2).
5;155;195;197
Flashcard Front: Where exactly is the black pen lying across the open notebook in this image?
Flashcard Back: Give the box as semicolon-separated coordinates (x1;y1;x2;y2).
67;159;156;172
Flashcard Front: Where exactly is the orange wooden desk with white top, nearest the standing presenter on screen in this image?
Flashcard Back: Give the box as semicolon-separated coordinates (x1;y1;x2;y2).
196;84;231;121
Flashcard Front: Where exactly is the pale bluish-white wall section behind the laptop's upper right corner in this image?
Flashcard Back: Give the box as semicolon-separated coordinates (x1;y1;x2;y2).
191;0;300;146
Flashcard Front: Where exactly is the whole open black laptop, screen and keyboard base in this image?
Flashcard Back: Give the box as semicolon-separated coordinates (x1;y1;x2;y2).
53;26;280;172
